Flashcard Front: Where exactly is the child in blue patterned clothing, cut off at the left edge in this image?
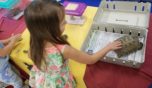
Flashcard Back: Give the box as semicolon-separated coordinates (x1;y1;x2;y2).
0;34;23;88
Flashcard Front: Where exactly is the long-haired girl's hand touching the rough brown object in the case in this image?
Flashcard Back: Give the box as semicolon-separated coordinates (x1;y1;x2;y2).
106;41;122;50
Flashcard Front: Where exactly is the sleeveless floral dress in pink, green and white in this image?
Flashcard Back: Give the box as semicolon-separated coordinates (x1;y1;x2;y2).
29;45;76;88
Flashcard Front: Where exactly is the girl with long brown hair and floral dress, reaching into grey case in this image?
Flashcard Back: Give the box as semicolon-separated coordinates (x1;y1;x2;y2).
24;0;121;88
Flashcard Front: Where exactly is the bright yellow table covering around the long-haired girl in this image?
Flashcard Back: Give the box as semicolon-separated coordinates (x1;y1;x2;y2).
11;6;97;88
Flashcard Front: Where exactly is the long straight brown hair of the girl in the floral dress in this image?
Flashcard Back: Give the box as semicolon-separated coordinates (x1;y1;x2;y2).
24;0;69;69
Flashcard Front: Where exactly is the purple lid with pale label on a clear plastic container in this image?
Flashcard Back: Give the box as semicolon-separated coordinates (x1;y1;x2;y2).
63;1;87;16
